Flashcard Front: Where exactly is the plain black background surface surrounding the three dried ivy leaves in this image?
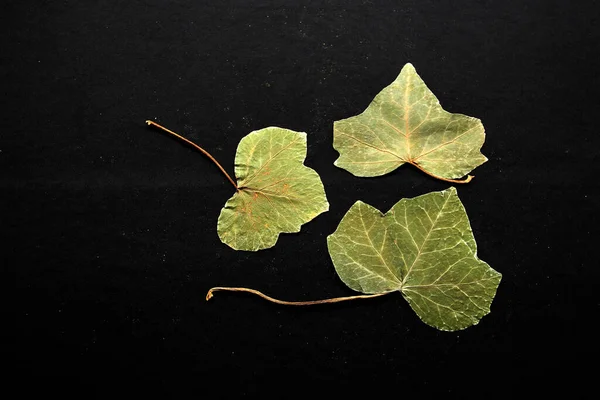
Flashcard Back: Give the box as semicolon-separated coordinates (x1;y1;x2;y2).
0;0;600;398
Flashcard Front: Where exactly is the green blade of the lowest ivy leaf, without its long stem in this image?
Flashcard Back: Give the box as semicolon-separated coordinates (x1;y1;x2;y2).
327;188;501;331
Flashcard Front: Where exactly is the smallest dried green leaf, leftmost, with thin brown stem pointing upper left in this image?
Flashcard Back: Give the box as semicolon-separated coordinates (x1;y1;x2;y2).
146;121;329;251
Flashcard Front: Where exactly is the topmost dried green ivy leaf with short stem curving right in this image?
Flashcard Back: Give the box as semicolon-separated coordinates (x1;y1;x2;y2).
333;64;487;183
